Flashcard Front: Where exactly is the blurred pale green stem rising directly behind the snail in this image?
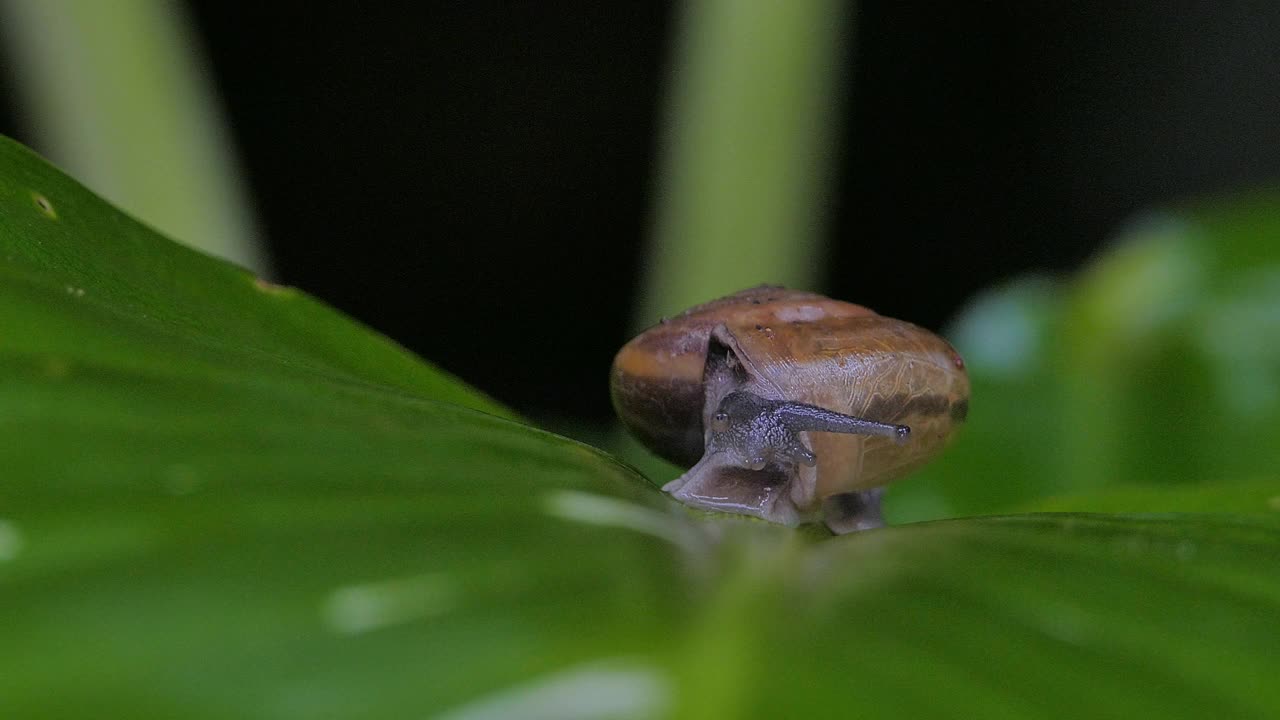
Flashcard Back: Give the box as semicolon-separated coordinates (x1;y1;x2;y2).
637;0;854;325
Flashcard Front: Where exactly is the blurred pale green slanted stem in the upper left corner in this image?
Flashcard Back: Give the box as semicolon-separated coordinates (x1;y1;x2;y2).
0;0;266;273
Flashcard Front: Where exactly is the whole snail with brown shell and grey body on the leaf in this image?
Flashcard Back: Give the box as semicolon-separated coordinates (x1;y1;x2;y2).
609;286;969;533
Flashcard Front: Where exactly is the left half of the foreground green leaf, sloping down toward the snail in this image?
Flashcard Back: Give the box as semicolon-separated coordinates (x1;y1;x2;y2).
0;134;675;717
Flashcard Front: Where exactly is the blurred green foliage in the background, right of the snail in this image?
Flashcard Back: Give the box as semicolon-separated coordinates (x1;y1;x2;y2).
890;192;1280;520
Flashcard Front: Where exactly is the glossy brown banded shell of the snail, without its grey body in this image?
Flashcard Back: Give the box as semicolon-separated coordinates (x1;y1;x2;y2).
609;287;969;503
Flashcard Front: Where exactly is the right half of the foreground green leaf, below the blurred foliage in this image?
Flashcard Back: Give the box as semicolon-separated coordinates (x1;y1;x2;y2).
680;515;1280;717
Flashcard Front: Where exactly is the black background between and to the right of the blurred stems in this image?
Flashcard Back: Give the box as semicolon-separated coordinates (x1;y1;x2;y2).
0;0;1280;421
